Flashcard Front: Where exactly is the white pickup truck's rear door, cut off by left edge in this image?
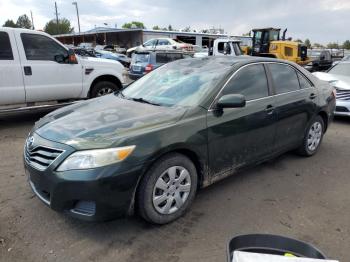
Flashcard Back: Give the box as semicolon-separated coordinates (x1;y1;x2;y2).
0;31;25;105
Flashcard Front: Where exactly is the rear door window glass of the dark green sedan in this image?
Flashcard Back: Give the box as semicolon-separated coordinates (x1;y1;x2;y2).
269;64;300;94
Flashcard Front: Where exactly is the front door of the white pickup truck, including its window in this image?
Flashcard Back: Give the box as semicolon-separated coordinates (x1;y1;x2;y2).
16;33;83;102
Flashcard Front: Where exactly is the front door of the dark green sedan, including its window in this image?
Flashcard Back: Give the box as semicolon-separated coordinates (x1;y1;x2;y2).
207;64;276;180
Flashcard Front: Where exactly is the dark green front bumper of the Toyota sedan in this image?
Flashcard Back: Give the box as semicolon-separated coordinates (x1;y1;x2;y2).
24;133;142;221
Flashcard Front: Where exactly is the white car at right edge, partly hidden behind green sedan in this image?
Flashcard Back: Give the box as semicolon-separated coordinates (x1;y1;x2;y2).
314;61;350;116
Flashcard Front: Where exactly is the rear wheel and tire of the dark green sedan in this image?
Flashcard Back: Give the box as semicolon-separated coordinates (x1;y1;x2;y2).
297;116;325;157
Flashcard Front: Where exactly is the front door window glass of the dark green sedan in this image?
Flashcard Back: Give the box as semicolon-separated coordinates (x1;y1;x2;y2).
222;65;269;101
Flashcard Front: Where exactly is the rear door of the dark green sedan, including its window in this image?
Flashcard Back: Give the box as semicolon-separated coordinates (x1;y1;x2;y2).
268;63;317;151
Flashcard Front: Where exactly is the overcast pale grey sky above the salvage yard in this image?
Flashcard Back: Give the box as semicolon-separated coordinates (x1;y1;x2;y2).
0;0;350;44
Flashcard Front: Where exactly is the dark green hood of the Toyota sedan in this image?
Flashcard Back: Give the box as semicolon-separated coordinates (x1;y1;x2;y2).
34;94;186;149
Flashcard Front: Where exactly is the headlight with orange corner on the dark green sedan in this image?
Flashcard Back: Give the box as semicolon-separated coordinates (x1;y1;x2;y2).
57;146;135;172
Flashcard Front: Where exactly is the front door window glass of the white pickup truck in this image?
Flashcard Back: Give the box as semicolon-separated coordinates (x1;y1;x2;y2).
21;33;68;61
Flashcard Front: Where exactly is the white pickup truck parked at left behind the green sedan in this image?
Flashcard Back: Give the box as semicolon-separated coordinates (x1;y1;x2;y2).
0;27;124;113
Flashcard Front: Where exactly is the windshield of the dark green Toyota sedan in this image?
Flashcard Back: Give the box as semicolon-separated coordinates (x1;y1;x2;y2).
122;59;227;106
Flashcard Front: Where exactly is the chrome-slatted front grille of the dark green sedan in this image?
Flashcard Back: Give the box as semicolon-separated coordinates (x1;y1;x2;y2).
24;145;63;171
